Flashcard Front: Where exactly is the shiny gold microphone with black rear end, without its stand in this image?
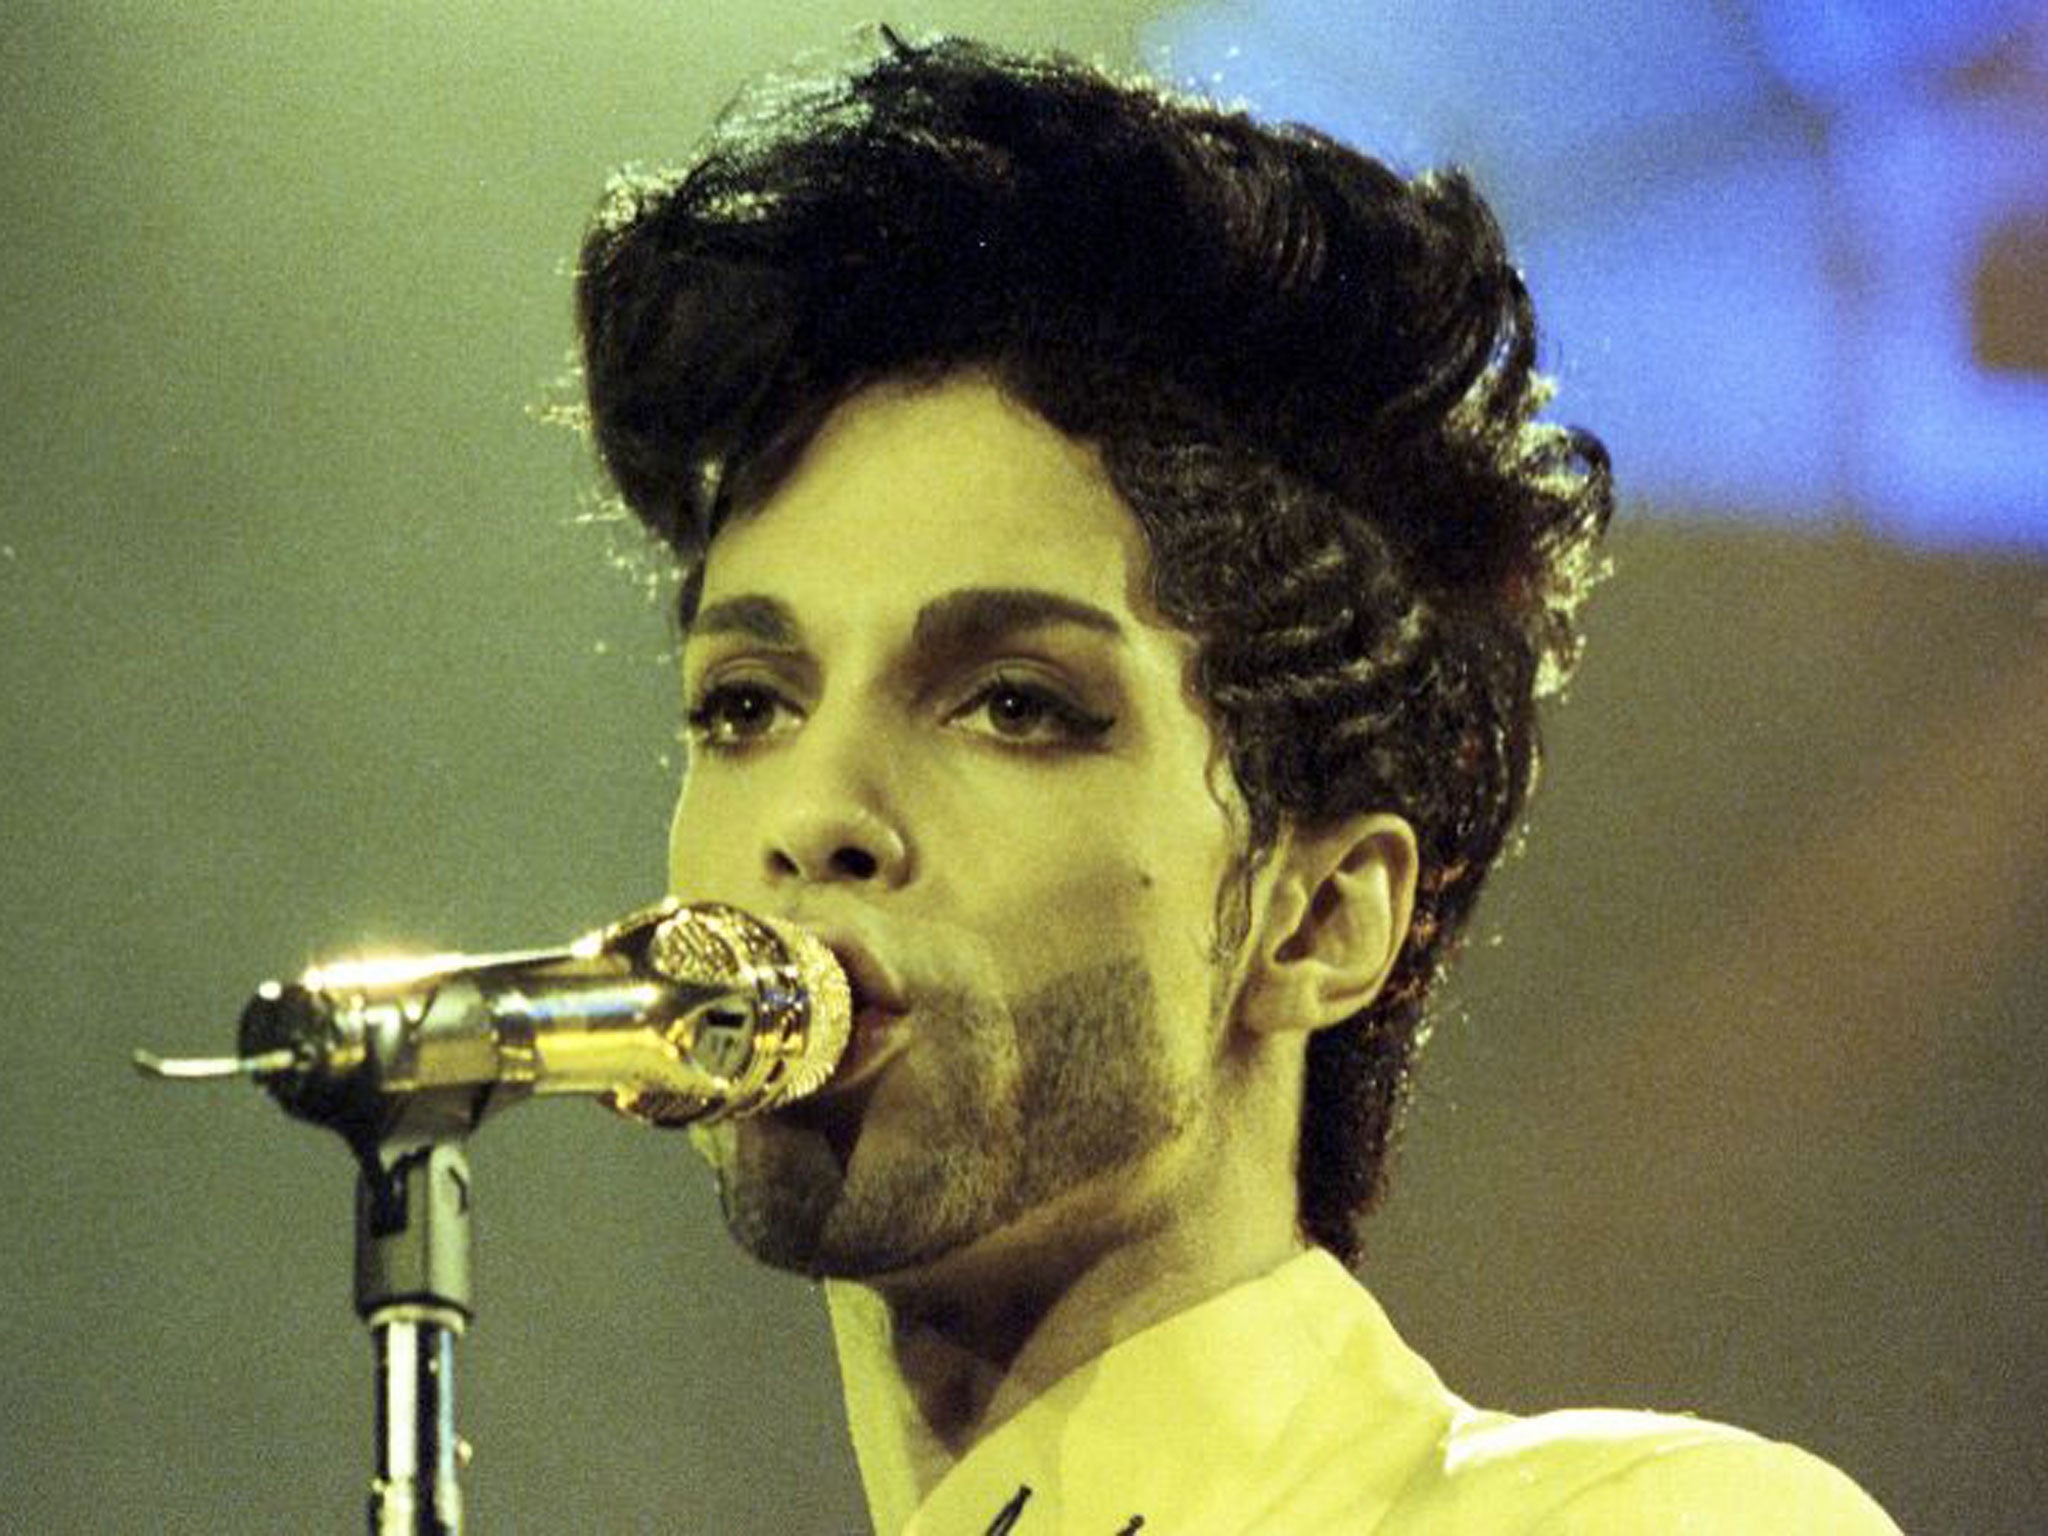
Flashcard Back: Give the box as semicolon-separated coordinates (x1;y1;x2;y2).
135;901;852;1151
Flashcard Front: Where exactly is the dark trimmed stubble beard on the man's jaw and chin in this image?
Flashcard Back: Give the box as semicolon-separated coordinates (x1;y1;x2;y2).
694;958;1202;1280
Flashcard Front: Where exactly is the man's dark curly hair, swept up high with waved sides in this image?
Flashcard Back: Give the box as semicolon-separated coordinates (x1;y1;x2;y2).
578;29;1612;1264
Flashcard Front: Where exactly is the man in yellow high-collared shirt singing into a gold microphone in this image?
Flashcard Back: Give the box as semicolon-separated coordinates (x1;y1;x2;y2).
578;33;1892;1536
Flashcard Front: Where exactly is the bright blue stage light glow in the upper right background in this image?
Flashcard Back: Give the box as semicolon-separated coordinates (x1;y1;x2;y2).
1147;0;2048;551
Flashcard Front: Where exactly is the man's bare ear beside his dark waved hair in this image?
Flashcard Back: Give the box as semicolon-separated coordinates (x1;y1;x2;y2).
1239;811;1419;1034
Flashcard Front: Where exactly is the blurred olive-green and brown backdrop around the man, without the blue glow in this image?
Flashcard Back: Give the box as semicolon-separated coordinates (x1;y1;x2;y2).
0;0;2048;1534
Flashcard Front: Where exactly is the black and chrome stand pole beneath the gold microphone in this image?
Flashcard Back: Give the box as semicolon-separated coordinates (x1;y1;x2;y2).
356;1141;475;1536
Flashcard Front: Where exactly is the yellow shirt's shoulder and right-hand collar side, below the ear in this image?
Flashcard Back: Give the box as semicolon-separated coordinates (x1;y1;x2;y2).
903;1249;1898;1536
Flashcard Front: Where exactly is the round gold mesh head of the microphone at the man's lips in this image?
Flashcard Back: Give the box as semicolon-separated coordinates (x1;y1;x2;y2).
612;903;854;1124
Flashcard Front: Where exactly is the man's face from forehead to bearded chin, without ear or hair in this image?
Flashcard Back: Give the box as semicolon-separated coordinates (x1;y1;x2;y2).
670;375;1239;1278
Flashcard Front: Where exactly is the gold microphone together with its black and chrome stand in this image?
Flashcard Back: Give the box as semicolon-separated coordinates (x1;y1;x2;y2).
135;901;852;1536
